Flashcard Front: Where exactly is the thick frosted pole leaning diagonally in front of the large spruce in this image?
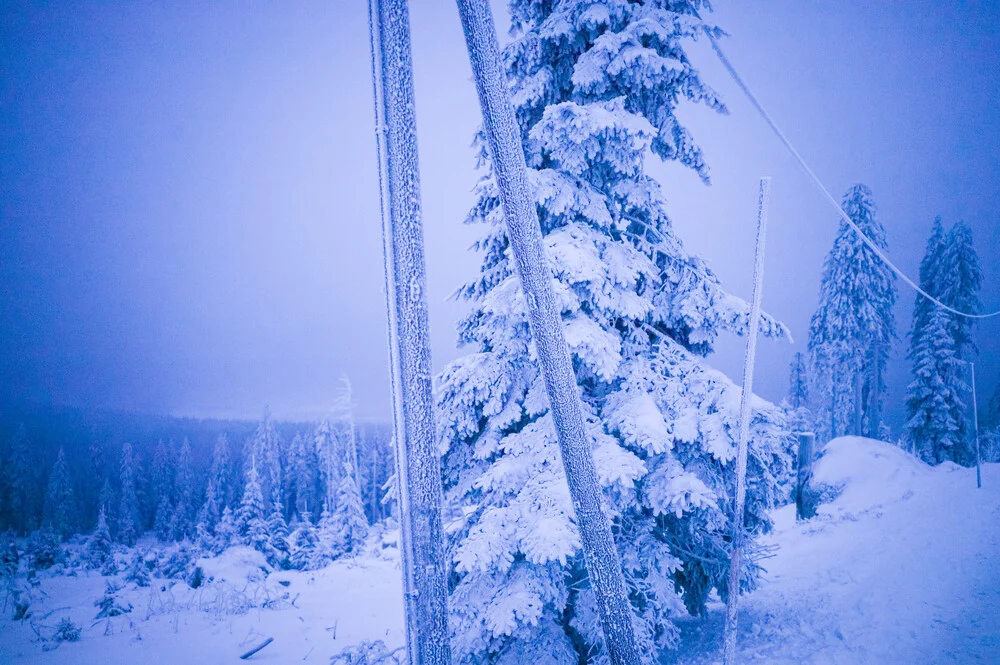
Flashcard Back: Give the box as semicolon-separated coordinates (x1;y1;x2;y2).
450;0;639;665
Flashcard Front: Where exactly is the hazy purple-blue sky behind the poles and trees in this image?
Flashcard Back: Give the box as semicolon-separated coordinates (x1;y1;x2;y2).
0;0;1000;425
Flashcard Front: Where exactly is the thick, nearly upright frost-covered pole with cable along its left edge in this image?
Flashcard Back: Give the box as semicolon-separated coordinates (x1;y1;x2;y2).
368;0;451;665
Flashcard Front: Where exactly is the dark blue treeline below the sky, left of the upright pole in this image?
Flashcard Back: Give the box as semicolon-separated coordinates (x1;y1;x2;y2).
0;396;393;540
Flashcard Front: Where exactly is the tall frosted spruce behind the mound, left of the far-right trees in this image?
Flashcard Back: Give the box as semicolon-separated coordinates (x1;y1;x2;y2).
809;184;896;438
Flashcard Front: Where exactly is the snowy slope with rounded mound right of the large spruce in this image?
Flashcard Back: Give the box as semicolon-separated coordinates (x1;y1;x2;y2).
664;437;1000;665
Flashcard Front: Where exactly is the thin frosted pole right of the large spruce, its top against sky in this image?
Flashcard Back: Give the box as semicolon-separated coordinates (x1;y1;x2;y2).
722;178;771;665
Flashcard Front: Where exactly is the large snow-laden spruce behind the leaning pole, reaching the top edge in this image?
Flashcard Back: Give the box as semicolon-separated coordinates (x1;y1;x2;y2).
438;0;790;664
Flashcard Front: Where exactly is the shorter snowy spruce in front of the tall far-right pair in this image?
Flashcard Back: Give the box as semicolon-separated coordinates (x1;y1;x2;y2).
906;307;965;464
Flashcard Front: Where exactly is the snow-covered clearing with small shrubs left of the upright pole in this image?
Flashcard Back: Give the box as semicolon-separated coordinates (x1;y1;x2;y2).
0;548;403;665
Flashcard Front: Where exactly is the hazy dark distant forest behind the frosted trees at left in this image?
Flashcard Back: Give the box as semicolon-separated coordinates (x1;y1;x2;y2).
0;396;393;535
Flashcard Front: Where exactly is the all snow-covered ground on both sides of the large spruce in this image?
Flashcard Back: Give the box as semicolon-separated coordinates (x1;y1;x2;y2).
0;438;1000;665
